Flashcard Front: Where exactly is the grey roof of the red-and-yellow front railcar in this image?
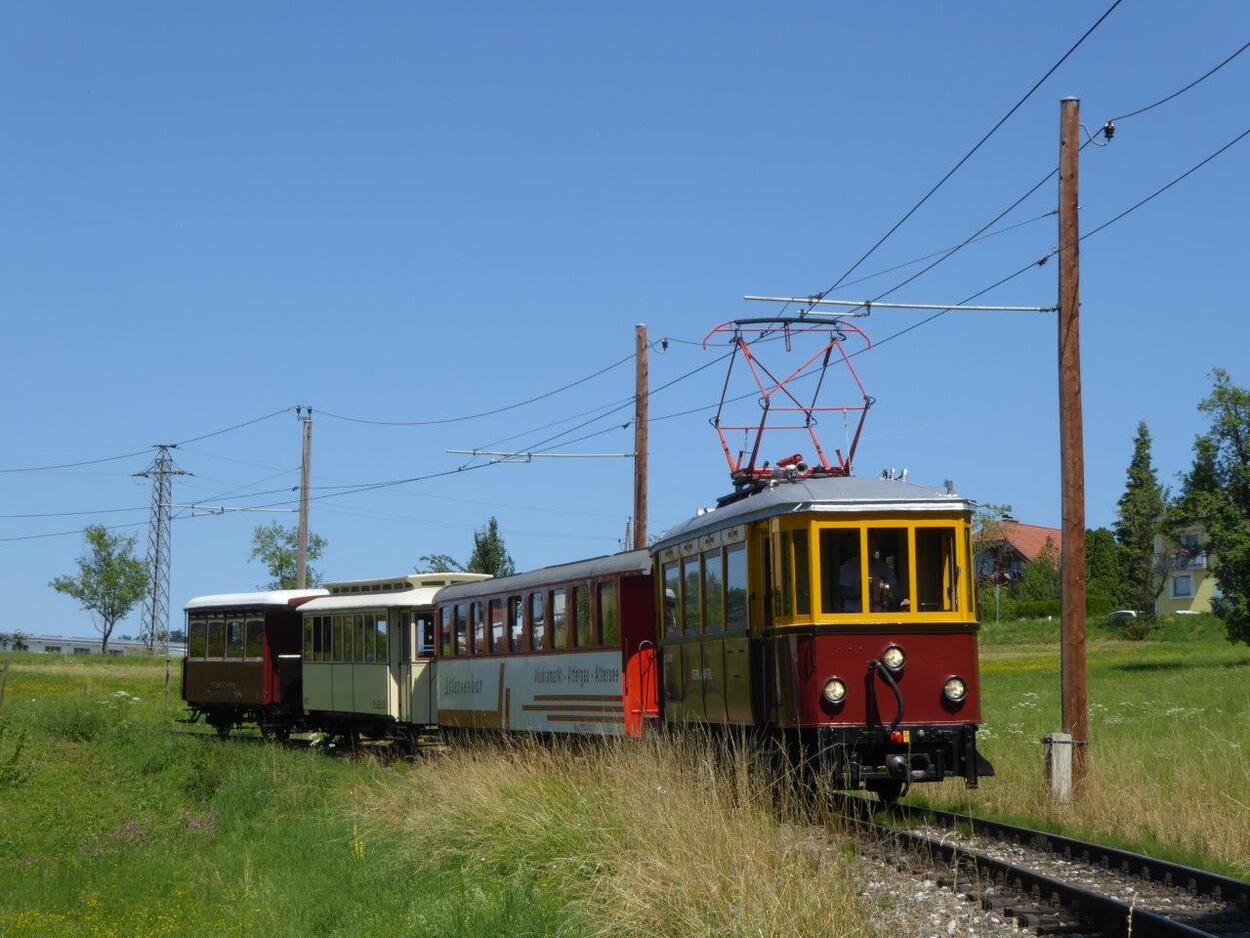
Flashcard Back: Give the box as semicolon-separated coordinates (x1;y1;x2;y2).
651;475;974;552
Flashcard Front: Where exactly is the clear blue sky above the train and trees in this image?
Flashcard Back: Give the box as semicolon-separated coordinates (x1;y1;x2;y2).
0;0;1250;633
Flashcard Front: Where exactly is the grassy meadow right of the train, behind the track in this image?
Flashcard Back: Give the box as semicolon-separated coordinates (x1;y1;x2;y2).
909;617;1250;877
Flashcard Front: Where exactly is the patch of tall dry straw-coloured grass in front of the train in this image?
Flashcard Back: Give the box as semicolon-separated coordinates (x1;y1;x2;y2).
353;738;868;937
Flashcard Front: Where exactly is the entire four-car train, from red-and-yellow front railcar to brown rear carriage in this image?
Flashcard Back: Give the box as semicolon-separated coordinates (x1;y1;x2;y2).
184;472;994;799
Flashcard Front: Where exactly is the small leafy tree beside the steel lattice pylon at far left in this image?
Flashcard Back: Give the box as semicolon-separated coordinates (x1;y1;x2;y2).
48;525;149;654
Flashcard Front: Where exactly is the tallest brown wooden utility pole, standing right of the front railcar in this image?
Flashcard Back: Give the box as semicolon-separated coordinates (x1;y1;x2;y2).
1059;98;1089;792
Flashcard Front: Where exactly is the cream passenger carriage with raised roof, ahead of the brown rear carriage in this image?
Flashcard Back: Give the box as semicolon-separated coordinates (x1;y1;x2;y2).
300;573;489;737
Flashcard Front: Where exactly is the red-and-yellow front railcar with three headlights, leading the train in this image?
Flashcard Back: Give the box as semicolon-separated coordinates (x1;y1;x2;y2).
653;473;993;799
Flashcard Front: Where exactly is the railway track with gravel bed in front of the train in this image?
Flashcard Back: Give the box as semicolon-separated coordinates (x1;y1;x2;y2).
848;798;1250;938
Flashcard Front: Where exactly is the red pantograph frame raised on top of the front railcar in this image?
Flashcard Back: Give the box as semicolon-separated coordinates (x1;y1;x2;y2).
703;316;873;484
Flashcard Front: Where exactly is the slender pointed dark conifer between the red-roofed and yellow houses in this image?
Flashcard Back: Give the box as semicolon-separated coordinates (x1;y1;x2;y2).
1115;420;1168;619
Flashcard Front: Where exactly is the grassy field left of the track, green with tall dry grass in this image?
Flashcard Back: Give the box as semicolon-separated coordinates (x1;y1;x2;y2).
0;654;868;938
